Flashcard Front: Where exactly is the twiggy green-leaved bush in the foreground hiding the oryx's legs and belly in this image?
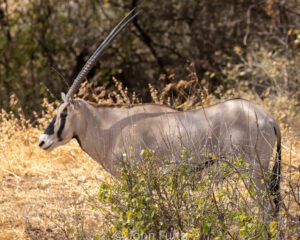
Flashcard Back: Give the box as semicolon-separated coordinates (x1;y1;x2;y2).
99;148;278;239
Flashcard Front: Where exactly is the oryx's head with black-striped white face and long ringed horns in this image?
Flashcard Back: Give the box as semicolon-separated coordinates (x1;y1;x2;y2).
39;9;138;150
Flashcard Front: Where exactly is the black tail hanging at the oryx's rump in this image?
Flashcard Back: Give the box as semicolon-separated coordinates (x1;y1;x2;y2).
270;124;281;216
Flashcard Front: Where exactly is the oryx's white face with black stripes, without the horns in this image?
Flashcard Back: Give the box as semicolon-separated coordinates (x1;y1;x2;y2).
39;103;76;151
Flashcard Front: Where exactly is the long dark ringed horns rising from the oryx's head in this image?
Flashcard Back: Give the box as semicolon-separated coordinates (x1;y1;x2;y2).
66;8;139;100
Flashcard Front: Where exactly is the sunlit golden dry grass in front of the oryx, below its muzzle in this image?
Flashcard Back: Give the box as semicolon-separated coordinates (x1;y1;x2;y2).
0;108;109;239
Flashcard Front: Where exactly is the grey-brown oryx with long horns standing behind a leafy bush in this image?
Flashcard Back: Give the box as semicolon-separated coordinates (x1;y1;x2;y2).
39;11;281;216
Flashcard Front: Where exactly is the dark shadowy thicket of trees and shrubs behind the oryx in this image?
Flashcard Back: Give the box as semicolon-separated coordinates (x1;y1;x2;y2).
0;0;300;116
